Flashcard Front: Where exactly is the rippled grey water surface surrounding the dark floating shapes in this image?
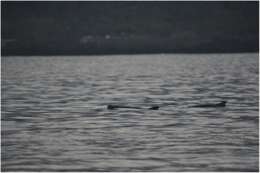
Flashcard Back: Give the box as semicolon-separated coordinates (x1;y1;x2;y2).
1;53;259;171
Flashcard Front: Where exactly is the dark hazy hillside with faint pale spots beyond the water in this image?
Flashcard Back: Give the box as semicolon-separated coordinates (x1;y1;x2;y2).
1;1;259;55
